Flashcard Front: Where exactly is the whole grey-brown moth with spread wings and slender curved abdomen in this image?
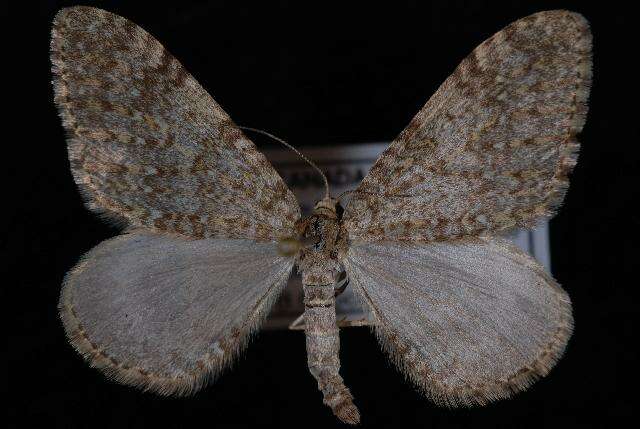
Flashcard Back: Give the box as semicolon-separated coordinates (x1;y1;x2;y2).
51;7;591;424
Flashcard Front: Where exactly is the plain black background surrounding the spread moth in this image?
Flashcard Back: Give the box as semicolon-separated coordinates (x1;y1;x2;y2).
7;1;640;427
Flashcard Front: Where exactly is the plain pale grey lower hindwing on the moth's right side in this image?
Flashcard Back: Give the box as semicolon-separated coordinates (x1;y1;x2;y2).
345;238;573;406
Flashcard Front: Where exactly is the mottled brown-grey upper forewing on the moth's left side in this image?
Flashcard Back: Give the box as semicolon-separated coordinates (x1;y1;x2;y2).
51;7;300;240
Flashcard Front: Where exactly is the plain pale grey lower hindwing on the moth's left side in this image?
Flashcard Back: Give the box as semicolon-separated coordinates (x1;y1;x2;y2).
60;232;293;394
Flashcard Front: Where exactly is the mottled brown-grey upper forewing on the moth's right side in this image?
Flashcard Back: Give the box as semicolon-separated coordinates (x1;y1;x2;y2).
345;11;591;241
